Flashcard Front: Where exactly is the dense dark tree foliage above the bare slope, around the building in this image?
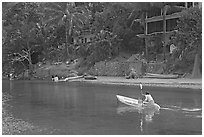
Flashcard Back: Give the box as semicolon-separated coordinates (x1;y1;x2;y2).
2;2;202;77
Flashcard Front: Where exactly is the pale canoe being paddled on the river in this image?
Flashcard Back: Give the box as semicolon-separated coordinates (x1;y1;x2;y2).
116;95;160;110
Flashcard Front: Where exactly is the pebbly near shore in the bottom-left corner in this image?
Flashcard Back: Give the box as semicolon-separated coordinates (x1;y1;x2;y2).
2;93;59;135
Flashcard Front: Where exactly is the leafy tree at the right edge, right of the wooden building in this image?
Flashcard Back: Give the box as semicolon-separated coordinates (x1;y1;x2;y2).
172;7;202;78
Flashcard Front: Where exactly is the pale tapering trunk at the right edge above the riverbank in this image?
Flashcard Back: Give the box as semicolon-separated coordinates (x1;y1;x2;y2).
191;53;202;78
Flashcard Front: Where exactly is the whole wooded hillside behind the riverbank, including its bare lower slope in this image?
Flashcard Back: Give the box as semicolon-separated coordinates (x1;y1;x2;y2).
2;2;202;78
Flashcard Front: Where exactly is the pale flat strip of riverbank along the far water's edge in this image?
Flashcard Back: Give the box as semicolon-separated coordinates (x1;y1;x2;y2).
72;76;202;89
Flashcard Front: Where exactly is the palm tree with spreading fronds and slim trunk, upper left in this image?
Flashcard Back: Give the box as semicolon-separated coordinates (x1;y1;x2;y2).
42;2;89;58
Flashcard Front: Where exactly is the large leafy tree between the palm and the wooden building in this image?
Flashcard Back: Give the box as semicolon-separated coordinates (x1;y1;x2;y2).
75;3;127;64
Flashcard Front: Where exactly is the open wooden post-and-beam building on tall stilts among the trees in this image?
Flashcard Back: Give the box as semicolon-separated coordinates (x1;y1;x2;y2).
135;2;202;60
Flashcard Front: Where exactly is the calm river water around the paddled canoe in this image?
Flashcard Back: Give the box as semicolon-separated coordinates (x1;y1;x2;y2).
2;80;202;135
